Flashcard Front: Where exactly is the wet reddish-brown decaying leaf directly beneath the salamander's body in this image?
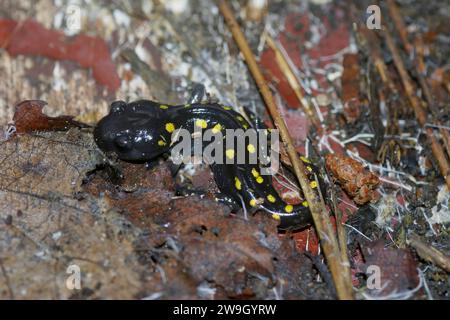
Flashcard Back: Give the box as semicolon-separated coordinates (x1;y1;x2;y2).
85;162;326;299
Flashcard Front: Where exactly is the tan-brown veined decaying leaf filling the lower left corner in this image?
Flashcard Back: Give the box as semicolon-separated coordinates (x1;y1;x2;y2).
0;129;146;299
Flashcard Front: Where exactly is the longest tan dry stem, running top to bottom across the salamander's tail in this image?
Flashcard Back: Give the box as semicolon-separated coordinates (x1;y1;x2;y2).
219;1;353;299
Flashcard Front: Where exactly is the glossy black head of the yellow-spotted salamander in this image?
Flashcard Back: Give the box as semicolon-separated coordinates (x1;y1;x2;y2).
94;101;173;162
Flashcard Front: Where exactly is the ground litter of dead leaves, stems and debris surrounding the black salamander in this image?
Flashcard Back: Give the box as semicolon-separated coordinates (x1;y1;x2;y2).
0;0;450;299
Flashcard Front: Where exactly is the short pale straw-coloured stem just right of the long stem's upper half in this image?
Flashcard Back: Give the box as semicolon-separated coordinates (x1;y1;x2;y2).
265;34;322;133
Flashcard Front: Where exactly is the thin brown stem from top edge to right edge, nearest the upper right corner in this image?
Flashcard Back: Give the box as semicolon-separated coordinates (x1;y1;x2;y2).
387;0;450;156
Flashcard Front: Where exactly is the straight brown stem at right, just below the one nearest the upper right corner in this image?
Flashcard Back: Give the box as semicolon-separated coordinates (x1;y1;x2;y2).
383;29;450;188
